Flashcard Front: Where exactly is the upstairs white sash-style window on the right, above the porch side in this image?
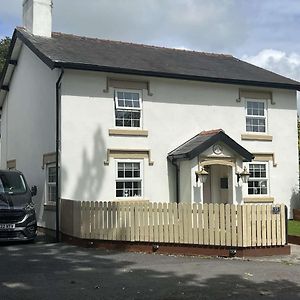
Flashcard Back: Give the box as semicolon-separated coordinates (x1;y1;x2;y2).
246;100;267;132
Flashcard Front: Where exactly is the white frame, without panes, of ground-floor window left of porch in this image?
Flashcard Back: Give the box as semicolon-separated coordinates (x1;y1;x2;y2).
114;159;144;199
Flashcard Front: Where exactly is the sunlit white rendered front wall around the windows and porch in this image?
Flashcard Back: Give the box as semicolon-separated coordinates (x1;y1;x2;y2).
62;71;298;216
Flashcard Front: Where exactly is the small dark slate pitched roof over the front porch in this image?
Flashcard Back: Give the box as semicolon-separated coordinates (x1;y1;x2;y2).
168;129;254;161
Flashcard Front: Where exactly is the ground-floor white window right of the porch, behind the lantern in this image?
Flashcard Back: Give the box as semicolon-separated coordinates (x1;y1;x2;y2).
248;163;268;195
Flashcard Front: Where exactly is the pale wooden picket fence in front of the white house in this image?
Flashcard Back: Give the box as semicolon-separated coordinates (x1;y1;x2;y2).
61;200;286;247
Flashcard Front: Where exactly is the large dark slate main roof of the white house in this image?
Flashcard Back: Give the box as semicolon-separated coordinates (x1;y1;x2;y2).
4;28;300;90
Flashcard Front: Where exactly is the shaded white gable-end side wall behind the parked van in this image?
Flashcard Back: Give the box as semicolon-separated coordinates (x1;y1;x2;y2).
1;46;58;228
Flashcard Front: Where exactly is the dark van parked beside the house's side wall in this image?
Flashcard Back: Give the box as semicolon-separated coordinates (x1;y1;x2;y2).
0;170;37;242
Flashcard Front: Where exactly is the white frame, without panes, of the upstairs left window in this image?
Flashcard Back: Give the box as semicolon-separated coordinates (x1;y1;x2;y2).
114;89;143;129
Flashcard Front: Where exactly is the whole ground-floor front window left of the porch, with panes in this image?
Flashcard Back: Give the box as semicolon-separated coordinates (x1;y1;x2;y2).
116;160;143;197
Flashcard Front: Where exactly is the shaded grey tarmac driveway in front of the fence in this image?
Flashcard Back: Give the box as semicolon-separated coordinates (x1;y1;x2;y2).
0;237;300;300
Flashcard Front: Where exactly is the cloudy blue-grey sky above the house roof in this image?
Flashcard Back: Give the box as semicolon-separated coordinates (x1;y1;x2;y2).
0;0;300;108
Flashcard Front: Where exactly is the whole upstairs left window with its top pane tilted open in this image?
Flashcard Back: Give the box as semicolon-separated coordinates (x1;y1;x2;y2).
115;90;142;127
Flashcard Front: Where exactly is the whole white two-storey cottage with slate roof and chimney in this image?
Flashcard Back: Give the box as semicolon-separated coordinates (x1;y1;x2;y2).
0;0;300;228
